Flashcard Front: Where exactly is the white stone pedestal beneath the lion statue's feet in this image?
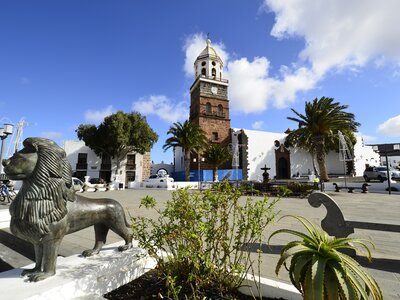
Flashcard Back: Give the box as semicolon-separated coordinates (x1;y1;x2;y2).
0;241;156;300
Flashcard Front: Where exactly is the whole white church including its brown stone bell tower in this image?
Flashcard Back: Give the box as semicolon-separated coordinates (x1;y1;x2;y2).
174;39;379;180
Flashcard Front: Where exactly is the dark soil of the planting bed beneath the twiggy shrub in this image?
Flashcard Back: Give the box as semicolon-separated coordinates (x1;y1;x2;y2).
104;270;284;300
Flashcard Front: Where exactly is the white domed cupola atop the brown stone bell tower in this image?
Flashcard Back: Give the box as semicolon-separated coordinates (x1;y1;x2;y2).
194;38;224;80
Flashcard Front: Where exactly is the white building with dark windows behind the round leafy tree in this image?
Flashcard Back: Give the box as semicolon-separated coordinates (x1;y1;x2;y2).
64;140;151;186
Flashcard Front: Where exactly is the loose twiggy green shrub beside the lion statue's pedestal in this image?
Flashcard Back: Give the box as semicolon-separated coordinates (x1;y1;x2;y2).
133;182;276;299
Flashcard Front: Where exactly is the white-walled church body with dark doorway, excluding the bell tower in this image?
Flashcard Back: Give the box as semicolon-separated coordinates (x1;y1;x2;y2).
235;129;379;180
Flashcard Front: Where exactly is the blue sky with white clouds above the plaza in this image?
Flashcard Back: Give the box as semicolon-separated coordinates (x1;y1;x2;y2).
0;0;400;162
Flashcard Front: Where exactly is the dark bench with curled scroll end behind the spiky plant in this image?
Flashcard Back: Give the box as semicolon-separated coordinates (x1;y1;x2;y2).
308;192;400;238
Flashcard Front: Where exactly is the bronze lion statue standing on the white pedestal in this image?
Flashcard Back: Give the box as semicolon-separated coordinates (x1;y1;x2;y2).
2;138;132;281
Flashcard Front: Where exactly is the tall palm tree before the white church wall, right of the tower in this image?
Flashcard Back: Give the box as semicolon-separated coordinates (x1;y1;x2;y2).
288;97;360;181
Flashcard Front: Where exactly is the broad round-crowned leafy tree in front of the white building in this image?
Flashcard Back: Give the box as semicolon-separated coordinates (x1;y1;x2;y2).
76;111;158;174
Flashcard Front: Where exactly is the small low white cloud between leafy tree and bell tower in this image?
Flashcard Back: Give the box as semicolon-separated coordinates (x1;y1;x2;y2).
132;95;189;123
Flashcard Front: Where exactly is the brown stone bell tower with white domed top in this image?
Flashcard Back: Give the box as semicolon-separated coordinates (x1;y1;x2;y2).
189;39;231;145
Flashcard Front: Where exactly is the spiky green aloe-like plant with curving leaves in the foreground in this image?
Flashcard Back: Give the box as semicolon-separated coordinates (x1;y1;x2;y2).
268;216;383;300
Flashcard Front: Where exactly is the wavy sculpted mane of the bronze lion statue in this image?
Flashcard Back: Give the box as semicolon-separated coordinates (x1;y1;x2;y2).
10;138;75;238
